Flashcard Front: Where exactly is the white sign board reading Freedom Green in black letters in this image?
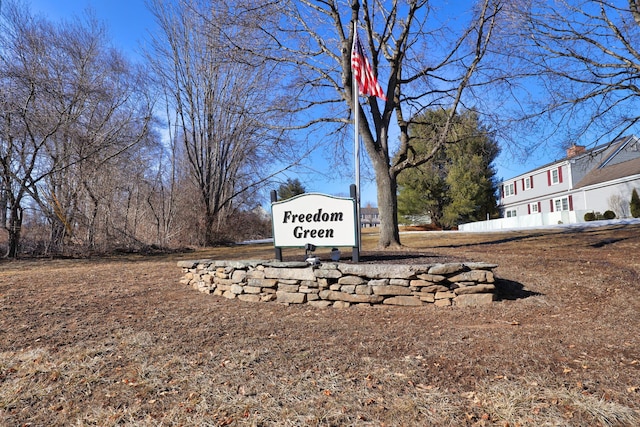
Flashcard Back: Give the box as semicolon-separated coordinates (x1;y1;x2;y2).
271;193;357;247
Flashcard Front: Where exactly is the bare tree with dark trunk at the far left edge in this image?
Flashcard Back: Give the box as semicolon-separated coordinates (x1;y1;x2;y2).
0;5;61;257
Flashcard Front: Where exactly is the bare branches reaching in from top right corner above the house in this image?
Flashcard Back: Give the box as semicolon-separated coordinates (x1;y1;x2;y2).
499;0;640;145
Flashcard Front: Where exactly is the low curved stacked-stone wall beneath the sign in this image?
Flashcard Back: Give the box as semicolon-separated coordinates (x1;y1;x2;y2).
178;260;497;307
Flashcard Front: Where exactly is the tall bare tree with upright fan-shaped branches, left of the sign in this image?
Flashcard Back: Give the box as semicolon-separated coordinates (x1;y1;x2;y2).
149;0;292;244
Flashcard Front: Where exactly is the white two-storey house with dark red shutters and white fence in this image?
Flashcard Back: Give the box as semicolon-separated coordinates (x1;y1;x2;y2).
460;135;640;231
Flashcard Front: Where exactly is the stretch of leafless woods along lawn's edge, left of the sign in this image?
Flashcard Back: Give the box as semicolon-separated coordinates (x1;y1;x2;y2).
0;1;286;257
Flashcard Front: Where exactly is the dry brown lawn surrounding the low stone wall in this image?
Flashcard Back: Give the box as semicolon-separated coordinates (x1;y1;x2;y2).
0;225;640;427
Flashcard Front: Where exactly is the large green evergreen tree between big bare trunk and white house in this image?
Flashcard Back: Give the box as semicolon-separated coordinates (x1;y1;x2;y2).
398;110;500;228
